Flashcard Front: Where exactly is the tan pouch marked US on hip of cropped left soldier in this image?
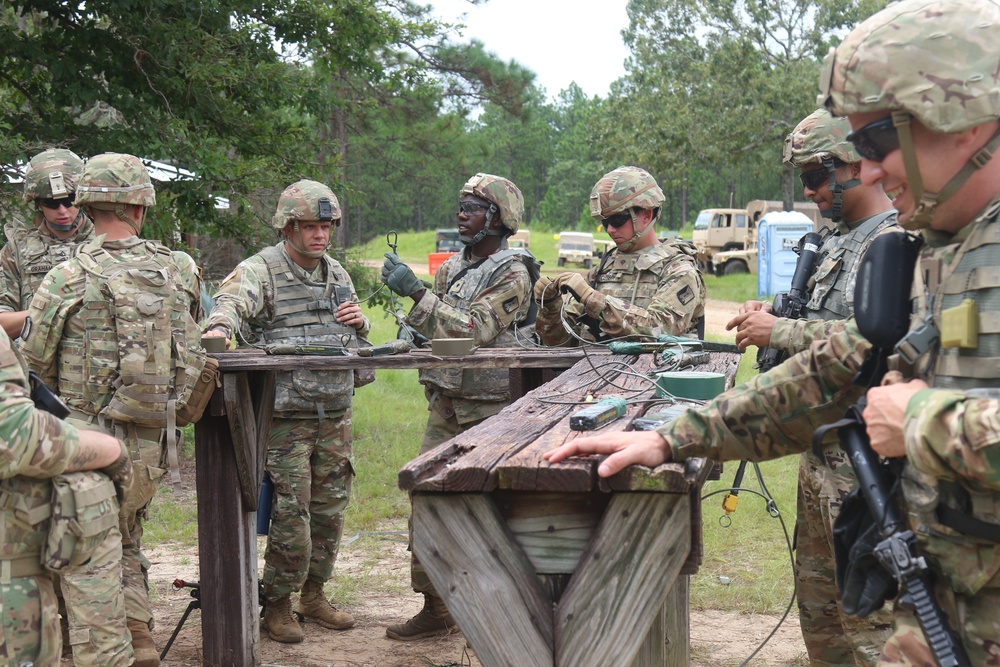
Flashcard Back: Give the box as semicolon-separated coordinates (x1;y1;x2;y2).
42;470;118;572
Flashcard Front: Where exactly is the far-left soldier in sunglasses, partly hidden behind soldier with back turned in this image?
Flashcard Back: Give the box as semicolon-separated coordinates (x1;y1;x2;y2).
0;148;94;338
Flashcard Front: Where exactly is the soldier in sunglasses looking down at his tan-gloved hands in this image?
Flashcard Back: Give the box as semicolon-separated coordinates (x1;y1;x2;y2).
535;167;705;346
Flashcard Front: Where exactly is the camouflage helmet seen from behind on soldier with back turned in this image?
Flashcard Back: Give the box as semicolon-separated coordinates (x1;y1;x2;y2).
75;153;156;234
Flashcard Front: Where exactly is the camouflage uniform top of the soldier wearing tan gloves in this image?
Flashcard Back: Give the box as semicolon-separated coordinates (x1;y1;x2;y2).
535;242;706;346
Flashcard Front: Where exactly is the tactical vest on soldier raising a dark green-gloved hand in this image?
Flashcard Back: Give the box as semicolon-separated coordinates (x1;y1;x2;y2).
420;248;538;401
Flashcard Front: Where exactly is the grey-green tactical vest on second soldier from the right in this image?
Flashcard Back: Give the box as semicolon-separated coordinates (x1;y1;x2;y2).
804;209;896;320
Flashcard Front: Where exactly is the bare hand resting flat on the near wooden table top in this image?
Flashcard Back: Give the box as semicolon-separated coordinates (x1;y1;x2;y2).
542;431;671;477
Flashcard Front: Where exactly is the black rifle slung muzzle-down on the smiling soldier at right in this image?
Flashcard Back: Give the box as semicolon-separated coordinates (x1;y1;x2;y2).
813;234;971;667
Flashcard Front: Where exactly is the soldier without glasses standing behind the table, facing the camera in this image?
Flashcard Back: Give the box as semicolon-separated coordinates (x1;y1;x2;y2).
205;180;370;643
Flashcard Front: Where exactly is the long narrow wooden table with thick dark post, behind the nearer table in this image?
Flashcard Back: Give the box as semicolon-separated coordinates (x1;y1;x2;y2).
195;348;583;667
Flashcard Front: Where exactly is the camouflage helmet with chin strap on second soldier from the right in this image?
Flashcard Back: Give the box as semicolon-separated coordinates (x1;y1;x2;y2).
782;109;861;222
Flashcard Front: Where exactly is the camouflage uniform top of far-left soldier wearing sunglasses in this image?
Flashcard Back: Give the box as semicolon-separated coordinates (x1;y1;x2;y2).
0;216;94;313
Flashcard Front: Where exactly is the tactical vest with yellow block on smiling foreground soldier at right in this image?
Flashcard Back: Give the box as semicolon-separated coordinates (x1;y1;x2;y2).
903;200;1000;595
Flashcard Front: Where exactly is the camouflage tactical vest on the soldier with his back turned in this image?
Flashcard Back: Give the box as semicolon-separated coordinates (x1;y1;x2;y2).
68;241;213;428
